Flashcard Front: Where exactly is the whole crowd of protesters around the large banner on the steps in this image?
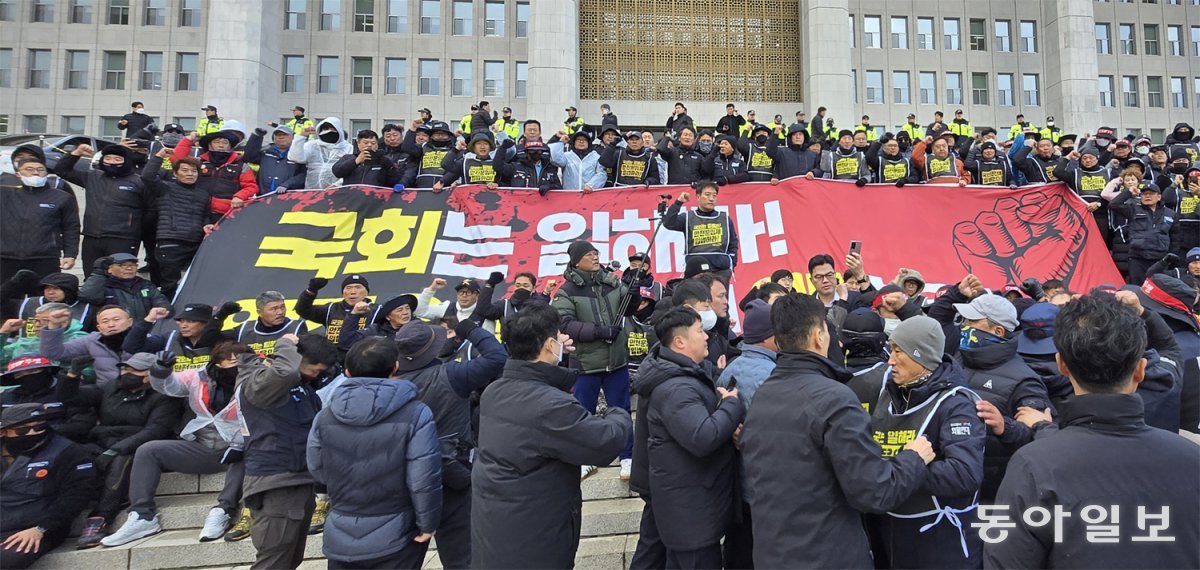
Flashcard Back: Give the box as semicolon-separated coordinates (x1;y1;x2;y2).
0;101;1200;569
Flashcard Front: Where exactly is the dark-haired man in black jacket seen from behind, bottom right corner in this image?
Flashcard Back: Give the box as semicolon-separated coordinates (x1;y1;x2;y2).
980;294;1200;569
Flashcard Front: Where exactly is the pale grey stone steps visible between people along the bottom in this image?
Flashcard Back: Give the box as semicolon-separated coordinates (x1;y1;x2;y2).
34;467;642;570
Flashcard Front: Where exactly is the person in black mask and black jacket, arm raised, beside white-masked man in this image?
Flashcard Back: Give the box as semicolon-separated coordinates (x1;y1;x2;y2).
54;144;154;272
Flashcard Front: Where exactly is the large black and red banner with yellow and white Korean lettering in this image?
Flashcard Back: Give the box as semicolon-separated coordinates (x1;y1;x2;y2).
176;179;1121;331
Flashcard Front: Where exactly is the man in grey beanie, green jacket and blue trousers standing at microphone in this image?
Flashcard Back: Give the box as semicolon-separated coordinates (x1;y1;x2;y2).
551;241;637;479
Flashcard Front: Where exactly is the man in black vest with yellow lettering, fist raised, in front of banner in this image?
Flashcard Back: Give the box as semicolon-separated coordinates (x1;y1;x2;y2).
662;182;738;283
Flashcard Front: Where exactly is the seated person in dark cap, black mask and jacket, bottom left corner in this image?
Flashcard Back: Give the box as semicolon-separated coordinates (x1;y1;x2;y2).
0;403;100;569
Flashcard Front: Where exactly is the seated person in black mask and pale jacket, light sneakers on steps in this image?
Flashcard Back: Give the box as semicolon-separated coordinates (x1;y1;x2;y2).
100;342;248;547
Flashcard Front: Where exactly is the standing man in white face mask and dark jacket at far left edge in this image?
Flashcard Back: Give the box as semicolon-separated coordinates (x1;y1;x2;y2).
0;156;79;281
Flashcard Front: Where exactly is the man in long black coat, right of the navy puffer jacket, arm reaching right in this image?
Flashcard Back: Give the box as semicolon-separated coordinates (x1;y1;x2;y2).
470;305;632;569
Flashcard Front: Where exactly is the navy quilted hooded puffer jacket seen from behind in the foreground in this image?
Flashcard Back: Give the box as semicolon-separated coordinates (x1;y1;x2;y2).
307;378;442;562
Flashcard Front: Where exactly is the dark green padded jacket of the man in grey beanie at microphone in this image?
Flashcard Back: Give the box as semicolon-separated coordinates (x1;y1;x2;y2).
551;268;629;374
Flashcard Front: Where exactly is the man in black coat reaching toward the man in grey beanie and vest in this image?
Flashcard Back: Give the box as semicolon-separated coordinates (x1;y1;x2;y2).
740;294;934;569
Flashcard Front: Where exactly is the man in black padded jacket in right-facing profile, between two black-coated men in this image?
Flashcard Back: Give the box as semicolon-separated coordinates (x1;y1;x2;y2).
635;307;745;568
